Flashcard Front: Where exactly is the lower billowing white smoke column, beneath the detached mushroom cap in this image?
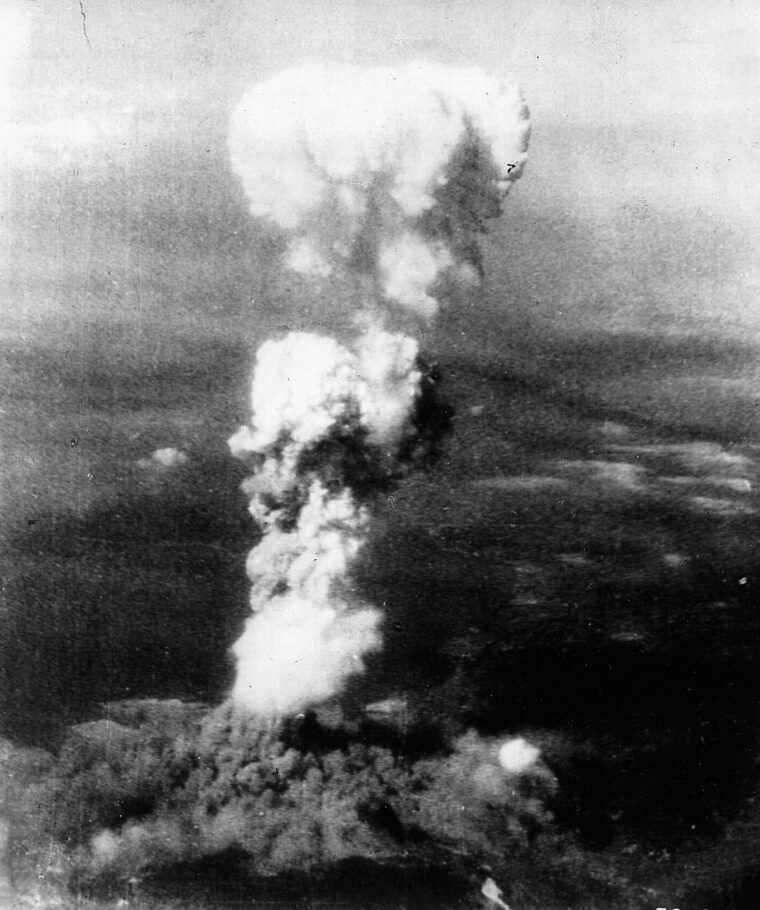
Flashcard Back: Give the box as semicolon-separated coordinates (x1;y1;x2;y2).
230;331;421;716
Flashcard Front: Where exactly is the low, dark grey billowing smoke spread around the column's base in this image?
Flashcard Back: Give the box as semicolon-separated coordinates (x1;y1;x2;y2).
5;701;556;890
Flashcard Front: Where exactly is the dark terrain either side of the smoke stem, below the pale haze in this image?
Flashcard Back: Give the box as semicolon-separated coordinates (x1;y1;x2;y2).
0;320;760;910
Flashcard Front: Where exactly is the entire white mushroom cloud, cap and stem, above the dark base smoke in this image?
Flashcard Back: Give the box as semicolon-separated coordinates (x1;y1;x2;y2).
229;64;529;717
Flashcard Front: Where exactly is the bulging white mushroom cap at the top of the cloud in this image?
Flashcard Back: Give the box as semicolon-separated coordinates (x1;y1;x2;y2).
229;63;529;319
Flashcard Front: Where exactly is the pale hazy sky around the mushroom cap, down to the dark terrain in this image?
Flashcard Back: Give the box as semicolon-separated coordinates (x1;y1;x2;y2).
0;0;760;536
